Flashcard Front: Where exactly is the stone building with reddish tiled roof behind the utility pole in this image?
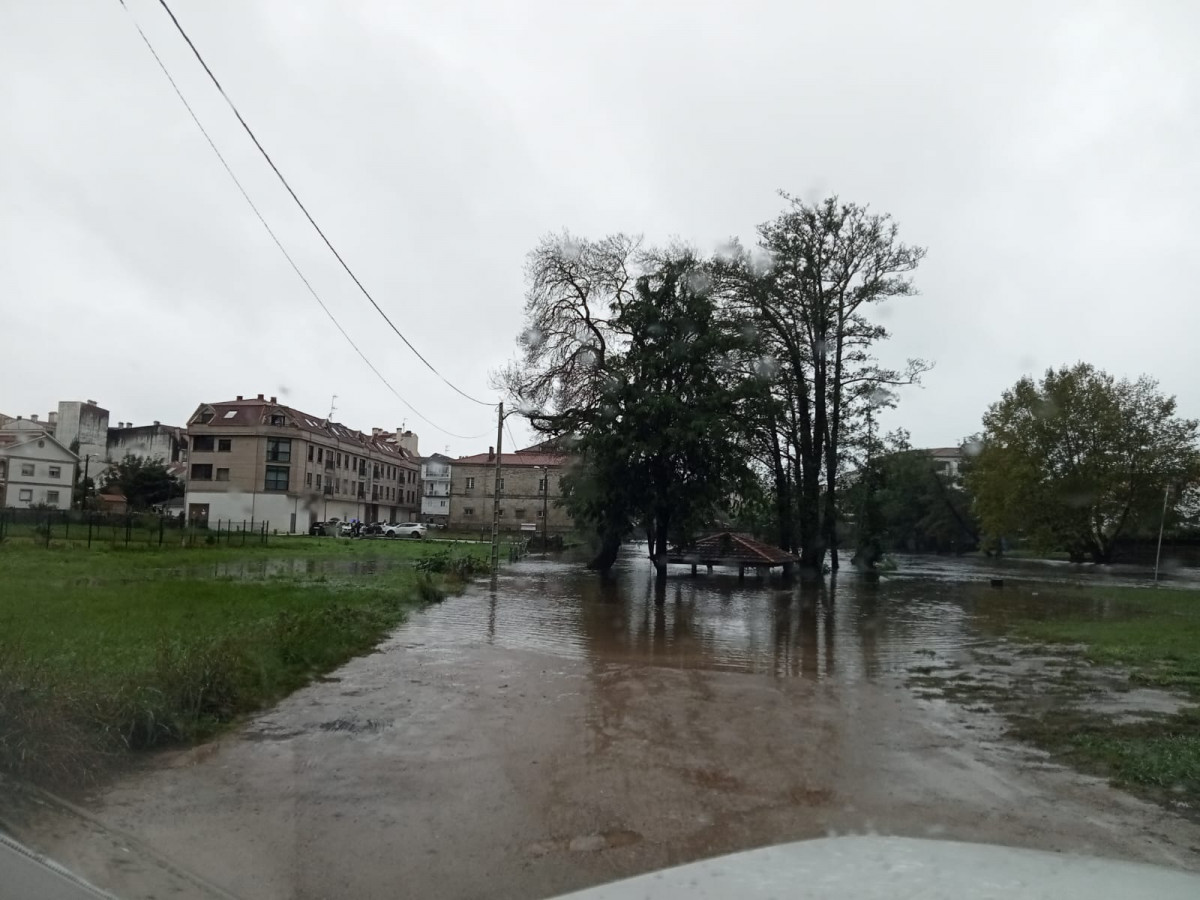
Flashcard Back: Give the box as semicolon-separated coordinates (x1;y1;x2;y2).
449;444;575;534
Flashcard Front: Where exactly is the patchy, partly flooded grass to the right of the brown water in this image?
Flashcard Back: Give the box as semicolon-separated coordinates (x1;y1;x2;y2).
960;588;1200;817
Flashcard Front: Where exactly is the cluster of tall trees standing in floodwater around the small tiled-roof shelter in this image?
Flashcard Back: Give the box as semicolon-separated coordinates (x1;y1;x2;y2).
497;194;929;574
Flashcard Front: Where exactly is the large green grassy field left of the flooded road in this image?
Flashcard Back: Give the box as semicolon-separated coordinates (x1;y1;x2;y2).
0;538;486;788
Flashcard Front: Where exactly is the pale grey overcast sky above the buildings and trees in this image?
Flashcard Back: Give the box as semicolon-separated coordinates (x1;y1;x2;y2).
0;0;1200;455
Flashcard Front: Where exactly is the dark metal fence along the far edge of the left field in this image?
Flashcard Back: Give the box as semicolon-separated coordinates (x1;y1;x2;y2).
0;509;270;547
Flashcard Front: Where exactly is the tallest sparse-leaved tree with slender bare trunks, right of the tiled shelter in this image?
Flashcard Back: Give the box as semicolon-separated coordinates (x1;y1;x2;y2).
720;193;929;571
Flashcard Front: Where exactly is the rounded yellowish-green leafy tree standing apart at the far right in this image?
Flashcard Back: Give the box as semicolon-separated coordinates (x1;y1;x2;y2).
967;362;1200;563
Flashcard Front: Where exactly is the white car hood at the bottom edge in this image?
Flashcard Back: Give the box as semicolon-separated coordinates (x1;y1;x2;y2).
549;836;1200;900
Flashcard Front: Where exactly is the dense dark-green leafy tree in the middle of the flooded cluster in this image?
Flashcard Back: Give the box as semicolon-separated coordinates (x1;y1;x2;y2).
559;251;762;576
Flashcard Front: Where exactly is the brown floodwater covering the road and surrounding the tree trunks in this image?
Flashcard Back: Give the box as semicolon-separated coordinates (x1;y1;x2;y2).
14;558;1200;898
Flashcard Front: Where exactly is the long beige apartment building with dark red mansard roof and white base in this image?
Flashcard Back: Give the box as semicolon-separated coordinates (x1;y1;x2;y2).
185;394;420;533
